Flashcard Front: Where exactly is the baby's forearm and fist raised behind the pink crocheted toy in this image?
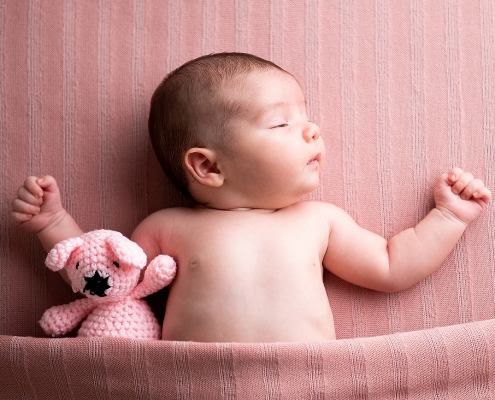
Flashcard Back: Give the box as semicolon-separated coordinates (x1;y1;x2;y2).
10;175;83;284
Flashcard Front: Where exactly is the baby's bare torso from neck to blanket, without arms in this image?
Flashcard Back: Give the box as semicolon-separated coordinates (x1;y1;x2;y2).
153;203;335;342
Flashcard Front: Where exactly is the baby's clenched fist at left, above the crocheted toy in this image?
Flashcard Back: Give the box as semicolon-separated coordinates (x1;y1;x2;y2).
10;175;66;233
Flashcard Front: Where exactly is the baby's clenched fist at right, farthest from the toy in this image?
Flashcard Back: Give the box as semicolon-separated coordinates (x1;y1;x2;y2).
435;168;492;225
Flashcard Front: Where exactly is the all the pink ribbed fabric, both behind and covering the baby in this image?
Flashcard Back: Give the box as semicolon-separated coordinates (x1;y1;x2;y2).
0;0;495;399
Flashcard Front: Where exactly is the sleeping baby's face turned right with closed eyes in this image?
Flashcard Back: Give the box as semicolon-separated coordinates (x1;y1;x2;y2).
217;70;325;208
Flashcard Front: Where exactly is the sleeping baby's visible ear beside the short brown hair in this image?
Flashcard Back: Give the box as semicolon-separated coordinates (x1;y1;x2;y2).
184;147;224;187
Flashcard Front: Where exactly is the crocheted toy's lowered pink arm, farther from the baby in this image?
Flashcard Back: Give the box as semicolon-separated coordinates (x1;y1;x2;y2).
40;299;96;337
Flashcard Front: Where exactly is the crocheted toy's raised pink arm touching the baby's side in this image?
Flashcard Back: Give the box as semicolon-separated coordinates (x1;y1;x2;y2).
130;255;177;299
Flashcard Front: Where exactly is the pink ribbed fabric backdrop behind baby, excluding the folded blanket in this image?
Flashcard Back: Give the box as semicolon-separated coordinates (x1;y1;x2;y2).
0;0;495;398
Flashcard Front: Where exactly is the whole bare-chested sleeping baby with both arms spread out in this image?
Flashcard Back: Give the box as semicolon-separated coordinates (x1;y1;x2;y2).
11;53;491;342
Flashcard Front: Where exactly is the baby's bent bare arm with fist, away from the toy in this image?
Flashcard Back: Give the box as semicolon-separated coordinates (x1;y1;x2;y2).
323;168;491;292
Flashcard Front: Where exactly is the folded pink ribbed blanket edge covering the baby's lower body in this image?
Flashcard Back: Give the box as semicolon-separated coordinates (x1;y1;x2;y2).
0;320;495;399
